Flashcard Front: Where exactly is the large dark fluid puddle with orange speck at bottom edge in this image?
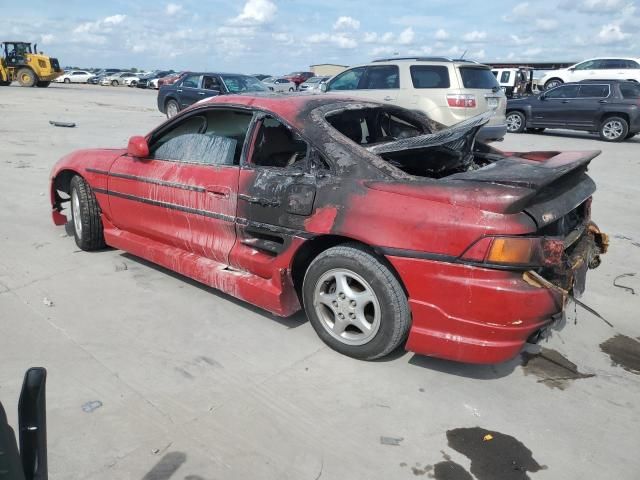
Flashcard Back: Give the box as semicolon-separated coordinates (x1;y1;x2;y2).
444;427;547;480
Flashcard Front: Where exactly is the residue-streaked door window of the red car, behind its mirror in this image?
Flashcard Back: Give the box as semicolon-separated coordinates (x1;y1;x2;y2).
149;109;253;165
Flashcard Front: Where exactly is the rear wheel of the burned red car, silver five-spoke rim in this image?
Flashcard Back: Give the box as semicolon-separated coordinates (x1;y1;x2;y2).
302;244;411;360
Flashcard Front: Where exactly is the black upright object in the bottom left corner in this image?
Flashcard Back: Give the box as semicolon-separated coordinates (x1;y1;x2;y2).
0;367;48;480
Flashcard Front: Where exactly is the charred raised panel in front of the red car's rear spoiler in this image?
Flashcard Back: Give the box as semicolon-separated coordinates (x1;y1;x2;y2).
367;111;494;155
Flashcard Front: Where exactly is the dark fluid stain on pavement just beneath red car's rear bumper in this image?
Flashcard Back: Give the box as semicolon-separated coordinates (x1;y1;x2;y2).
522;348;595;390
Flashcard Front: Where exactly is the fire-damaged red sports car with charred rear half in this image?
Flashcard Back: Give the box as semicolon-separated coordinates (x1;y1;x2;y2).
51;94;607;363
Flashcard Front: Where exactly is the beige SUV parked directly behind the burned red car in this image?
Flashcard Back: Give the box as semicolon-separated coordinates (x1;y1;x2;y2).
322;57;507;141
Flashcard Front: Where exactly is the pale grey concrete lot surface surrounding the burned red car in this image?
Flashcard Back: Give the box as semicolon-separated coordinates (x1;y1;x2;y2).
0;84;640;480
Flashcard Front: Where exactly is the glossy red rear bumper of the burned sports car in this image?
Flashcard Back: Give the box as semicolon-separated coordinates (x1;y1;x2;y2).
387;256;563;363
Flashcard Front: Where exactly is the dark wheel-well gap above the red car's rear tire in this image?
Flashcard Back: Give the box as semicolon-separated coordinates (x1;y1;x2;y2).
291;235;409;302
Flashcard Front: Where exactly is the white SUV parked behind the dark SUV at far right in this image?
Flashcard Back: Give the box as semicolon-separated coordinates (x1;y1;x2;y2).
538;57;640;90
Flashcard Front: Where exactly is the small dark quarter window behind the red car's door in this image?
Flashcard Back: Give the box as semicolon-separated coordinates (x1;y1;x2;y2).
251;117;308;168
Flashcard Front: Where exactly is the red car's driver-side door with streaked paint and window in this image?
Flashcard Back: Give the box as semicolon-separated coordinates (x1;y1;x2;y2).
109;107;253;265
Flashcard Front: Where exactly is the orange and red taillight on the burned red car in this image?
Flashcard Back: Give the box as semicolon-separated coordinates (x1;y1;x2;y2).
462;237;564;267
